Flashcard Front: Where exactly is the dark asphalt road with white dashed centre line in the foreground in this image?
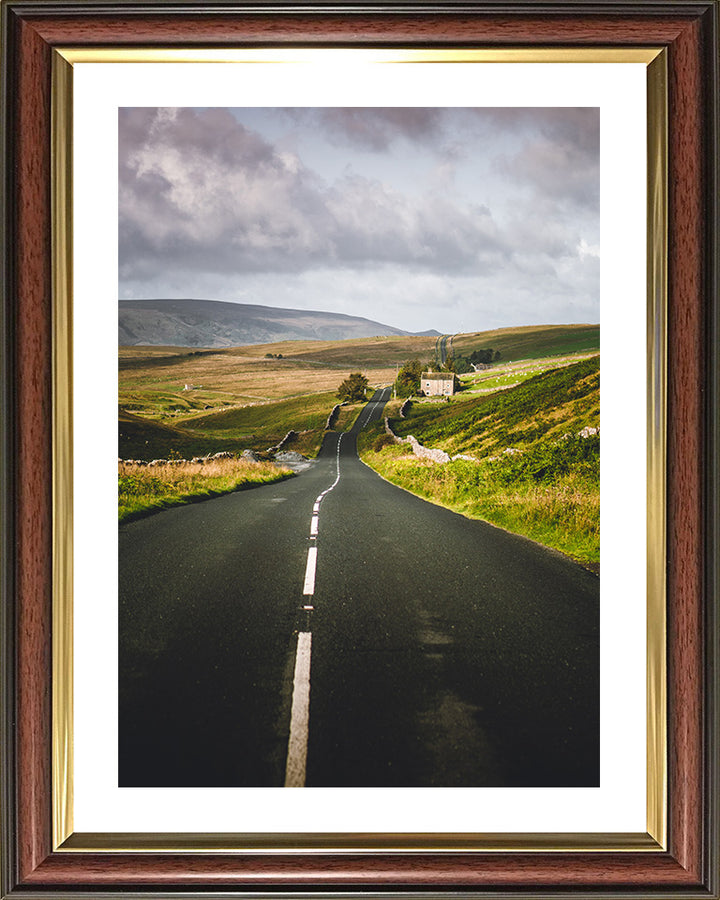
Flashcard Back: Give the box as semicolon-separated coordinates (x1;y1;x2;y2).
119;391;599;787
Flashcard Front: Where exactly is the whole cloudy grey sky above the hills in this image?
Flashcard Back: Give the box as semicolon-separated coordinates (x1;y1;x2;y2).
119;107;600;333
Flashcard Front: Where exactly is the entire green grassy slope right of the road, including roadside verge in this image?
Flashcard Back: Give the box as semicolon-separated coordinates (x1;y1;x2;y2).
359;357;600;571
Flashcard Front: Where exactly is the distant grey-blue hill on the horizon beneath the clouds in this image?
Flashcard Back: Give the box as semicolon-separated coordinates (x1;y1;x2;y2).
118;300;438;348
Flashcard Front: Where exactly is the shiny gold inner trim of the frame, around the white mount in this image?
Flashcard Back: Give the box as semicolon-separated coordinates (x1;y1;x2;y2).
51;47;668;853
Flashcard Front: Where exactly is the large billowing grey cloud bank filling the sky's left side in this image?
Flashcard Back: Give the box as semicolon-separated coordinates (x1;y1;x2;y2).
120;110;508;278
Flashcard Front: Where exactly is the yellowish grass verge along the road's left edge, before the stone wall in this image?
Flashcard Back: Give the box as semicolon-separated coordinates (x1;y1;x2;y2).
118;459;292;522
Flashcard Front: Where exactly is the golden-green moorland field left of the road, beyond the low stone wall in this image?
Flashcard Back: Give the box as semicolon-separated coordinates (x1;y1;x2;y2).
118;337;410;459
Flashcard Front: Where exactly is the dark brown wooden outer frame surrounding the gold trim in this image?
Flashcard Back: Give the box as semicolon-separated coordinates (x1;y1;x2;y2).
0;0;720;898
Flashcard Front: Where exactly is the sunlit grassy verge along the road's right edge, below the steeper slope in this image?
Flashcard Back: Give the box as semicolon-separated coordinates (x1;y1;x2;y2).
361;431;600;572
